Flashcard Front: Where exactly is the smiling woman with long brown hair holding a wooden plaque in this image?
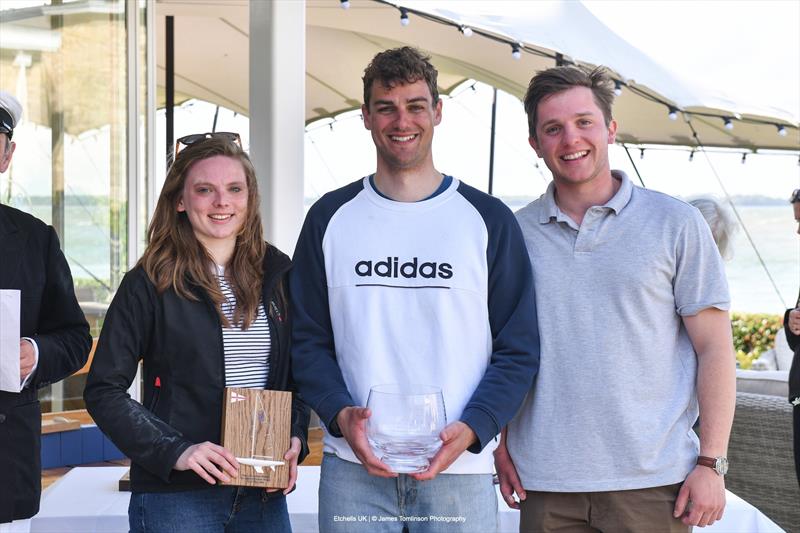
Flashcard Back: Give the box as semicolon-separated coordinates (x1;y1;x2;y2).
84;133;308;532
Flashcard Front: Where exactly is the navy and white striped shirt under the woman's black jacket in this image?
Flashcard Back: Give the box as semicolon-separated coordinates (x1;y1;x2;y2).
217;266;272;389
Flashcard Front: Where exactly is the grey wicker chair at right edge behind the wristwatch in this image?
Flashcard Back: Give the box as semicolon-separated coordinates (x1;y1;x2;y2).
725;392;800;532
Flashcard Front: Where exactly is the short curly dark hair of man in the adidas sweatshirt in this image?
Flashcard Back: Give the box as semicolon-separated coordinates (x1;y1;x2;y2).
361;46;439;108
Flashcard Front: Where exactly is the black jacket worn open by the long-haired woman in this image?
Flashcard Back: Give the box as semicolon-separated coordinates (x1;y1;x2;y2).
84;246;309;492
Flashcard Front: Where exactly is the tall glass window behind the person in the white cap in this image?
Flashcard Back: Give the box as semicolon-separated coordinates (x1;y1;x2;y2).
0;0;147;412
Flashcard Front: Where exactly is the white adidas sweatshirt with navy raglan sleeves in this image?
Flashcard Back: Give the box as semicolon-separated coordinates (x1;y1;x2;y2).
290;177;539;473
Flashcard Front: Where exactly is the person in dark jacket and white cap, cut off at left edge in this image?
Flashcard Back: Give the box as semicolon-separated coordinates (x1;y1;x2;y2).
0;91;92;531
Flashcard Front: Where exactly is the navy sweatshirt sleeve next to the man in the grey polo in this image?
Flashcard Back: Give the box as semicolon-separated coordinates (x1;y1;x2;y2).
461;191;539;453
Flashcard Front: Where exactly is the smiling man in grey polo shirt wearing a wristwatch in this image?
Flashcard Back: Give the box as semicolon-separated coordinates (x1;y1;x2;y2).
495;66;735;532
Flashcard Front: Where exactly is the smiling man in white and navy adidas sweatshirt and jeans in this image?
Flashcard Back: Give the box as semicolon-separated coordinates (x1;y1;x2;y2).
290;47;539;533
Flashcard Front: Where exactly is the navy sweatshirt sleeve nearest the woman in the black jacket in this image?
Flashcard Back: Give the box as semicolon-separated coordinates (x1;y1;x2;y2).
289;189;355;437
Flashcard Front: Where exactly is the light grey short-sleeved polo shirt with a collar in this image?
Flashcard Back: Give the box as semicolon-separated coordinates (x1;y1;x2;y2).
508;171;733;492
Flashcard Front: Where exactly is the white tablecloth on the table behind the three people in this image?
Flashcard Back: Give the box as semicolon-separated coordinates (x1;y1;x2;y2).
17;466;783;533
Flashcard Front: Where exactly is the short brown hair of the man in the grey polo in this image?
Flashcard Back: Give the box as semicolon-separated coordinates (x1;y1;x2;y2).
523;65;614;139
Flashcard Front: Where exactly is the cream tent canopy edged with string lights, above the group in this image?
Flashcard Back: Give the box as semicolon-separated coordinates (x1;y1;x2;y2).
156;0;800;150
